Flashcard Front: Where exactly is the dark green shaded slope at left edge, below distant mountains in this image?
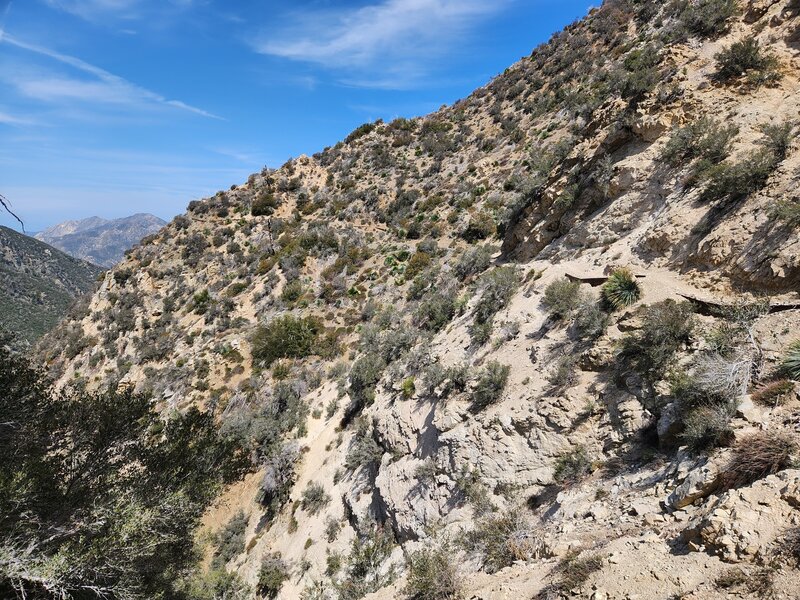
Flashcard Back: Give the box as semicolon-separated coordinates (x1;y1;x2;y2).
0;227;102;343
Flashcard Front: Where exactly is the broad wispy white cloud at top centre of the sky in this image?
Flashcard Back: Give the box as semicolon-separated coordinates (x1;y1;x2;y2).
253;0;509;88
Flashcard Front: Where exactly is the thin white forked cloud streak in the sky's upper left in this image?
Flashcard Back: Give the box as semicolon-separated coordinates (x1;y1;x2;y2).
0;32;222;119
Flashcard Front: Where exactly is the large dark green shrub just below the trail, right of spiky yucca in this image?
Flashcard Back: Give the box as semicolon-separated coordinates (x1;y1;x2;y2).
621;300;694;383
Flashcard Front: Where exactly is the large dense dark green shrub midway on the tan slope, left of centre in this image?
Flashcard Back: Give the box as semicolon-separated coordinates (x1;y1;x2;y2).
252;315;324;367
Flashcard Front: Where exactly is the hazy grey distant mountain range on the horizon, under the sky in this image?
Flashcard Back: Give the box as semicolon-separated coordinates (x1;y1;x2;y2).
34;214;166;267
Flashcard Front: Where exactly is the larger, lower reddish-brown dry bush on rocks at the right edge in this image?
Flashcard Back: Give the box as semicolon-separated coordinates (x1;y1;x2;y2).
723;431;798;488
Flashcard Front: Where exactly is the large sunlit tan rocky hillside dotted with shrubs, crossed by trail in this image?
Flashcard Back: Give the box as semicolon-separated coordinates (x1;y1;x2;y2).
40;0;800;599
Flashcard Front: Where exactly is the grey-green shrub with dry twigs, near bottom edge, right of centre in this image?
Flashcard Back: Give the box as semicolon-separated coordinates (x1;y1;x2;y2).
465;508;541;573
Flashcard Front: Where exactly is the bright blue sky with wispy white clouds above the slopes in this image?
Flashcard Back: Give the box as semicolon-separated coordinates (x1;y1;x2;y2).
0;0;592;230
